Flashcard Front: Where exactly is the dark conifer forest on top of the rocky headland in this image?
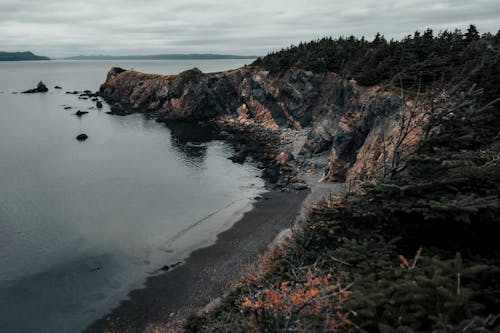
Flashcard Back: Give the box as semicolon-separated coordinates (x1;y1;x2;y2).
253;25;500;98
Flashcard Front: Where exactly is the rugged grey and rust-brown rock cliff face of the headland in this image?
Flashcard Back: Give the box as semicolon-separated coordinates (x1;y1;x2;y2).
100;68;426;181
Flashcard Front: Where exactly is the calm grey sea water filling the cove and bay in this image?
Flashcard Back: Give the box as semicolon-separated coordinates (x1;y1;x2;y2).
0;60;264;332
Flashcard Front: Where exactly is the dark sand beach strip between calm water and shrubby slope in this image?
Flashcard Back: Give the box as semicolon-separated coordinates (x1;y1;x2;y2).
85;191;309;332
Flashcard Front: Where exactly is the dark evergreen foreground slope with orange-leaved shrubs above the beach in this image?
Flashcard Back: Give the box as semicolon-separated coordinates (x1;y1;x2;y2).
185;28;500;333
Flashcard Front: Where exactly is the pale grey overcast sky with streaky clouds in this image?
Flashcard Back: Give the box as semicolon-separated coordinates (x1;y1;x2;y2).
0;0;500;57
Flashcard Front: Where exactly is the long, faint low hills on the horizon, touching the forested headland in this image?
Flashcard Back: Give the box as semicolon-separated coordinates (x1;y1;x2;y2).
64;53;257;60
